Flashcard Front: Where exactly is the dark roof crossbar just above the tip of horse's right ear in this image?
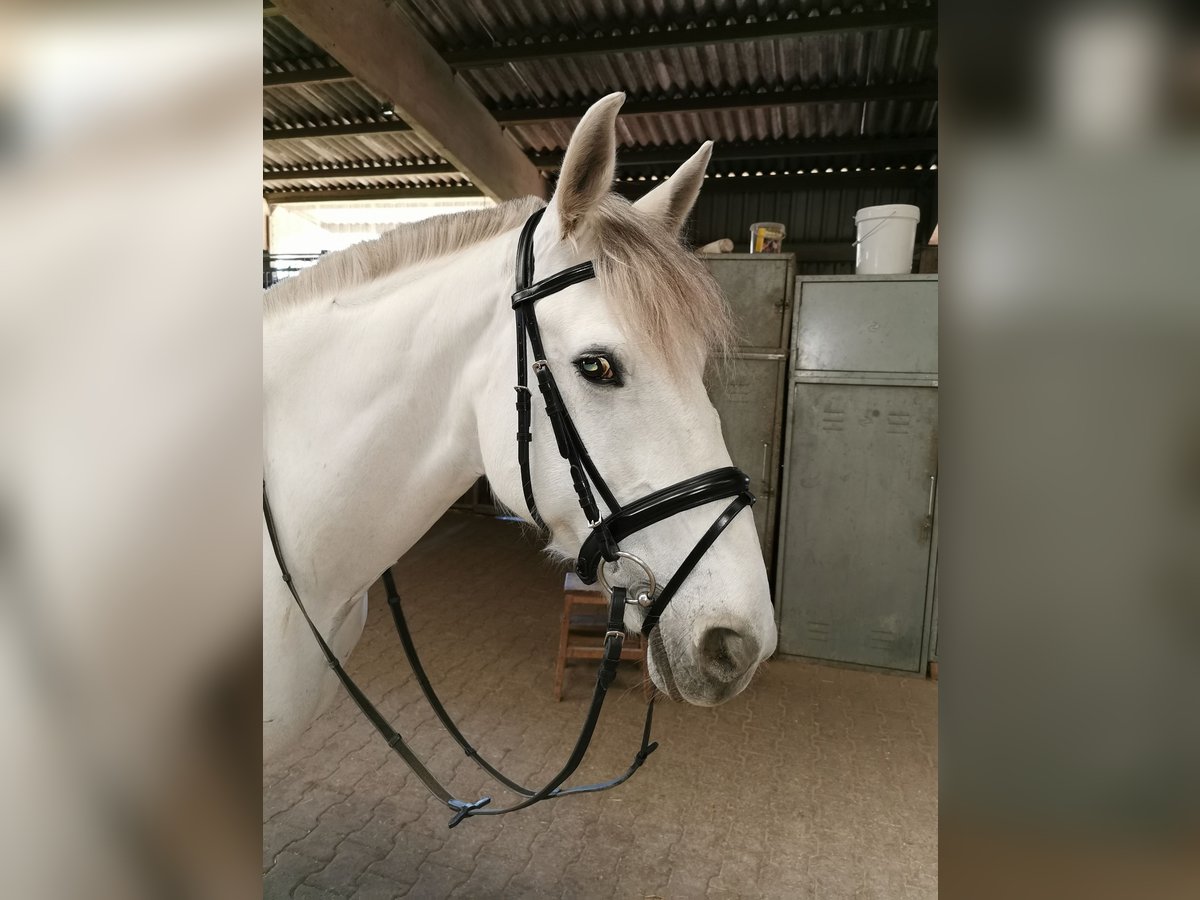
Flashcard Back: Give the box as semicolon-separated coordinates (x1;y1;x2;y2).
529;136;937;169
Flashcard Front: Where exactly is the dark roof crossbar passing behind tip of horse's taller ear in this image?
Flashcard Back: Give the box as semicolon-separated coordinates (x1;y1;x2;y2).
492;82;937;125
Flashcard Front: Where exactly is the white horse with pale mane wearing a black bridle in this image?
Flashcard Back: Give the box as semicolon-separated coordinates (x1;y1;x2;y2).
263;94;775;756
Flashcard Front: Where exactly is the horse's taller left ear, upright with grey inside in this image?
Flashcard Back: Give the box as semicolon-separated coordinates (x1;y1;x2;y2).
551;91;625;238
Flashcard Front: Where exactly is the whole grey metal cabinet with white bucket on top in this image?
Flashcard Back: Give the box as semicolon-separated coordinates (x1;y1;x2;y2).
776;276;937;672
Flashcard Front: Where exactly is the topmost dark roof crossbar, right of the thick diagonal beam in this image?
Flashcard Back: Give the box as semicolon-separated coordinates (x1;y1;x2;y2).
443;4;937;68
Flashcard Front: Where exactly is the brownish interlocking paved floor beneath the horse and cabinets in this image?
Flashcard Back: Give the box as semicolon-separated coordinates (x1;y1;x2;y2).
263;512;937;900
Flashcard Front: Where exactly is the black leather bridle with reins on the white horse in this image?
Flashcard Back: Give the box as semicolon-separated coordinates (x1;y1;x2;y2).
263;209;755;828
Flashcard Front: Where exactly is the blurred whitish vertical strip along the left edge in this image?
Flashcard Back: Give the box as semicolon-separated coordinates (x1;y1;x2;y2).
0;4;262;898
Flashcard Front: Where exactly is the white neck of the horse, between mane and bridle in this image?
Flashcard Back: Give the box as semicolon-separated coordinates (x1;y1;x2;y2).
263;235;515;601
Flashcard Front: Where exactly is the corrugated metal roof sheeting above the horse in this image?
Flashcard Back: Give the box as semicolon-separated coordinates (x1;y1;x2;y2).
264;0;937;240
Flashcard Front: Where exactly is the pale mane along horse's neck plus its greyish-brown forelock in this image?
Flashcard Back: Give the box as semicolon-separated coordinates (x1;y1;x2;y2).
264;193;733;371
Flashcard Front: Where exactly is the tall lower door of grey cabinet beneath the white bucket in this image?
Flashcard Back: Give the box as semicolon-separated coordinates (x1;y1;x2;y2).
779;383;937;672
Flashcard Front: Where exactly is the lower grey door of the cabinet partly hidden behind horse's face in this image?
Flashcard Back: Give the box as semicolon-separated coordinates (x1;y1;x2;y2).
708;354;787;571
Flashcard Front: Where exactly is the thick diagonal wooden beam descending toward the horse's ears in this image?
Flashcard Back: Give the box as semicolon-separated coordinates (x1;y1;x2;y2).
275;0;547;200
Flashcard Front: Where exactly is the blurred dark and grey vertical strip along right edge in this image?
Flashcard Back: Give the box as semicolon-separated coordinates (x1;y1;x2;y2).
940;4;1200;898
